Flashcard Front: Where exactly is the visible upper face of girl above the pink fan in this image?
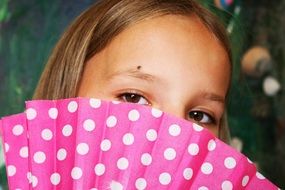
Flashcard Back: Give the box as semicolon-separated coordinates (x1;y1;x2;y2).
78;15;230;135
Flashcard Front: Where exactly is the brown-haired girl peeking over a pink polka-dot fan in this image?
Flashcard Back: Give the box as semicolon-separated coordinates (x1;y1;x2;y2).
34;0;231;141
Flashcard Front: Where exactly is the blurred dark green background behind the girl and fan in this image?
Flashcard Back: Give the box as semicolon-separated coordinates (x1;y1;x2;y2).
0;0;285;190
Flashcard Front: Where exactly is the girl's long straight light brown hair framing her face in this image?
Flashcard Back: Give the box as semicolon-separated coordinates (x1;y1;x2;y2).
33;0;231;140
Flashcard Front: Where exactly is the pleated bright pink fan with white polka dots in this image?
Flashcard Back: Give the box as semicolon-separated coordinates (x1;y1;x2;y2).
0;98;278;190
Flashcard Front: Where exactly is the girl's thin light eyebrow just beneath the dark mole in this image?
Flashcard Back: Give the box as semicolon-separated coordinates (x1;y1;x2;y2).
108;69;157;82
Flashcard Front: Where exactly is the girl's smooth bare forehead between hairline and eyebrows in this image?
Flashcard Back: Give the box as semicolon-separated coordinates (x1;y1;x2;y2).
87;15;230;95
